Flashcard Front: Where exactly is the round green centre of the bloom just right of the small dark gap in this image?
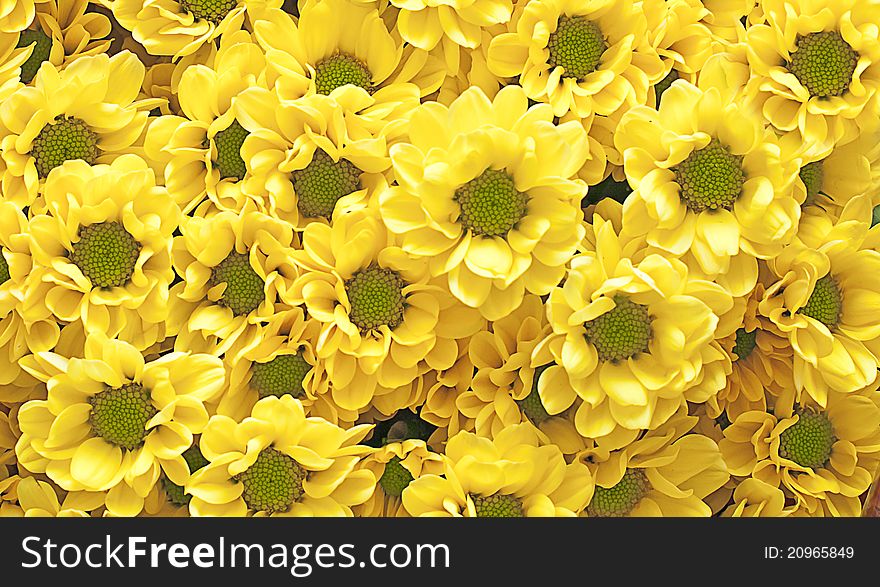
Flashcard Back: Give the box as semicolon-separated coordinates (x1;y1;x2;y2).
674;139;745;212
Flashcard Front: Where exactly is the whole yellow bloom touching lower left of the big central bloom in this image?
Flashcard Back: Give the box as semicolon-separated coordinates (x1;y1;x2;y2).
286;211;484;410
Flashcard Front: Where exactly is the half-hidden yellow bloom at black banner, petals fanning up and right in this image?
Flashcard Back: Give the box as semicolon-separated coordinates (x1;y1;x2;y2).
576;408;730;517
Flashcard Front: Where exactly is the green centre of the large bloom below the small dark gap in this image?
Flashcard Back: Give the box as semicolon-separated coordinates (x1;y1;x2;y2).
584;296;652;362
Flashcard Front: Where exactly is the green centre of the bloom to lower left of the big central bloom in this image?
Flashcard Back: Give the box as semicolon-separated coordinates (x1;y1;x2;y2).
345;265;407;332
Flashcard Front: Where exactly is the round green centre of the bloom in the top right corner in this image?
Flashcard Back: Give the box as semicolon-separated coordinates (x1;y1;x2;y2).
788;31;859;98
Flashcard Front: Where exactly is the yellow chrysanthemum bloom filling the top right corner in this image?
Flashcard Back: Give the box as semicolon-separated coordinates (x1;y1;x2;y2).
745;0;880;157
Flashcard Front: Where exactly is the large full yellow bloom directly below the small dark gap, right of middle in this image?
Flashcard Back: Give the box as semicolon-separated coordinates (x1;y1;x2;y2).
532;209;735;438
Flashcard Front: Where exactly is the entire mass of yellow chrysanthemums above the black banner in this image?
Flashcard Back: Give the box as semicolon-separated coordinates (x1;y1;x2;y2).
0;0;880;517
